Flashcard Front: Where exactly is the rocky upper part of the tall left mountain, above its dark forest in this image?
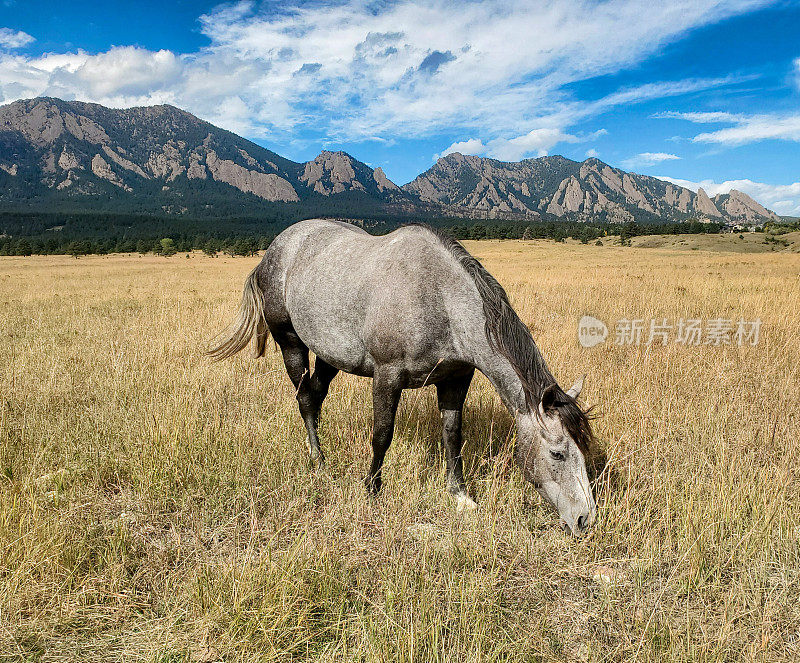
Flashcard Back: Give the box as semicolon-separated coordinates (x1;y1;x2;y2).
0;98;306;201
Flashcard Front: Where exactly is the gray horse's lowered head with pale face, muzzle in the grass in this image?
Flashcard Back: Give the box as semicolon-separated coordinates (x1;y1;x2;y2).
517;378;597;536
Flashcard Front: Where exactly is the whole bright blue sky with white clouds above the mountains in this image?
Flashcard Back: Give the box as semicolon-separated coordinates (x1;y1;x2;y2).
0;0;800;215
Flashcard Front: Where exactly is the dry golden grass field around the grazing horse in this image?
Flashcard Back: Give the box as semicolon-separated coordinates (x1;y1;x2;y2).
0;241;800;663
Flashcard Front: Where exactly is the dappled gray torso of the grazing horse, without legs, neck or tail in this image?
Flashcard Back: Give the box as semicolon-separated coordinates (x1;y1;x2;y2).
265;220;476;382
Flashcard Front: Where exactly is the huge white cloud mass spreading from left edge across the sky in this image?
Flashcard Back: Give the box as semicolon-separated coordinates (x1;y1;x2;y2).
0;0;768;145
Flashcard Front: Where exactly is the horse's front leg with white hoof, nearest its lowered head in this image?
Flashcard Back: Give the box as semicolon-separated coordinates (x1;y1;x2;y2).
436;371;475;509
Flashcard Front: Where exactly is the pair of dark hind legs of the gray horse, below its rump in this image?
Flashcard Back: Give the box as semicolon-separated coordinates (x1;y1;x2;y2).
275;331;337;467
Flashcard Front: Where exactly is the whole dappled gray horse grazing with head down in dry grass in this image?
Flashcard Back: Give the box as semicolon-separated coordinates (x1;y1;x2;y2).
209;219;596;535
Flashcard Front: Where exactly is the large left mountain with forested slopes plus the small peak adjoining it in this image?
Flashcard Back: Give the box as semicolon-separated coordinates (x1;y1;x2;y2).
0;98;411;216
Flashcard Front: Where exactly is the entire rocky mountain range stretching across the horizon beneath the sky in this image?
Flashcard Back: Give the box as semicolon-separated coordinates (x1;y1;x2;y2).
0;98;779;224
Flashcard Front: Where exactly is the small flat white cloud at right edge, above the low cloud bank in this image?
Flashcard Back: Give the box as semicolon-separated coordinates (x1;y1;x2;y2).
654;112;800;146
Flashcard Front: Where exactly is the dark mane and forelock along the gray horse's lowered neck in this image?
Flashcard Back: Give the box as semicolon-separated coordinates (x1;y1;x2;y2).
412;224;593;453
